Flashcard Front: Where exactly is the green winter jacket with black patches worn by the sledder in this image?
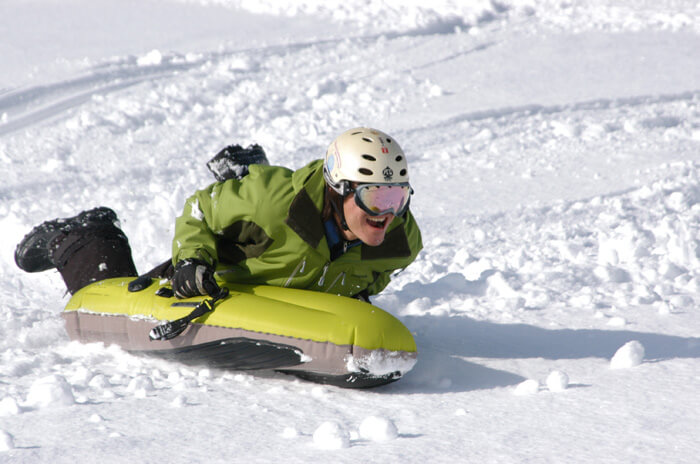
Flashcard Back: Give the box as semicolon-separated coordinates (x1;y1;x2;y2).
173;160;423;296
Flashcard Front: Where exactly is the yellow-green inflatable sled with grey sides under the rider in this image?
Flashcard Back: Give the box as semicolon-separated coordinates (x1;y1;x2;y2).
63;278;417;388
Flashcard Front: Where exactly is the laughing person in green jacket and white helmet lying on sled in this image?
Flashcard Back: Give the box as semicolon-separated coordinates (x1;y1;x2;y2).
15;128;422;300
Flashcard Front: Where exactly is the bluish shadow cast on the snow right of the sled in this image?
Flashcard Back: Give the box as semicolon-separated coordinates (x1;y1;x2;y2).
387;304;700;394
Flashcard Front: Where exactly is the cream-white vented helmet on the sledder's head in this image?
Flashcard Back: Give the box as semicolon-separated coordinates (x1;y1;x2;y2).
323;127;408;196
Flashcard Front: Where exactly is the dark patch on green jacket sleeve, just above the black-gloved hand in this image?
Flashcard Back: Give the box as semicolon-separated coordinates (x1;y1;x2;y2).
216;221;273;264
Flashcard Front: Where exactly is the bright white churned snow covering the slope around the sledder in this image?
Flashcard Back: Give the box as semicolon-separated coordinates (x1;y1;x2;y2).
0;0;700;464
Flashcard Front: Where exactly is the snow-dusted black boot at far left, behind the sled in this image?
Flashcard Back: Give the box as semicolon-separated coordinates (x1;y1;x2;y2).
15;206;117;272
